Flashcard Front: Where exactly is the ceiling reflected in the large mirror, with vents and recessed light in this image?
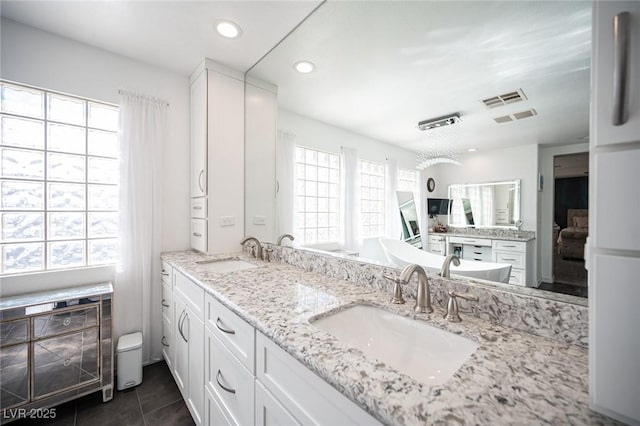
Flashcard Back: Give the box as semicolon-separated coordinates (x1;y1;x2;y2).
250;1;591;151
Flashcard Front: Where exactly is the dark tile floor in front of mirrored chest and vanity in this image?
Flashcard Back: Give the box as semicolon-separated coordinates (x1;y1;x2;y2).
11;361;194;426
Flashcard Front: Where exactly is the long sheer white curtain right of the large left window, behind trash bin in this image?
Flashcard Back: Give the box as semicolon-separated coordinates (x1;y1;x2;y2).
113;92;168;363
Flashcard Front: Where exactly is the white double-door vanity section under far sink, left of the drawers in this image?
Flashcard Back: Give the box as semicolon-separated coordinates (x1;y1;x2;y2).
173;271;204;425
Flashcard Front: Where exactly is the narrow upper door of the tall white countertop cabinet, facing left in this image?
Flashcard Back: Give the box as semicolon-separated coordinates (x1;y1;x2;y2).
191;69;207;197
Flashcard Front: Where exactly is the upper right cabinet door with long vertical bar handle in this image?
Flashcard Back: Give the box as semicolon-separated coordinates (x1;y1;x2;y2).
591;1;640;147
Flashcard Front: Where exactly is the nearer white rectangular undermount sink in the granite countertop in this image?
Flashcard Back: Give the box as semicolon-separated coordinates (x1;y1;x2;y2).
311;305;479;385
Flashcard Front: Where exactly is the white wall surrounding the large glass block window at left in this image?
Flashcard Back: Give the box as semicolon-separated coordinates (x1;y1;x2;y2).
0;19;189;346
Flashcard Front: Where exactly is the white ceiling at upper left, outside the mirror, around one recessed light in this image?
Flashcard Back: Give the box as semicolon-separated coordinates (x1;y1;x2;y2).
0;0;320;75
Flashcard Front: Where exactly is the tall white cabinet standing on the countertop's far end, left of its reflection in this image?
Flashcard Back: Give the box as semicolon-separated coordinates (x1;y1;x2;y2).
190;59;244;254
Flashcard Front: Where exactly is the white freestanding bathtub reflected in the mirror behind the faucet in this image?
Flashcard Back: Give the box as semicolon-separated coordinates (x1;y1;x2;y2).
379;238;511;283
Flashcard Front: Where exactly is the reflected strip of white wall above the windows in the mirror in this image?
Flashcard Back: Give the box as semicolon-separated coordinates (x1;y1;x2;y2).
278;109;416;169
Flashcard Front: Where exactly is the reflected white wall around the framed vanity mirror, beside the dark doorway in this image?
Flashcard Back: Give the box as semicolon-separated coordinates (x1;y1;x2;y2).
426;144;540;283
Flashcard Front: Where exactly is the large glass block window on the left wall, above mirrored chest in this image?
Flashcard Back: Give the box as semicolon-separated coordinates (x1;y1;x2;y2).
0;81;119;274
